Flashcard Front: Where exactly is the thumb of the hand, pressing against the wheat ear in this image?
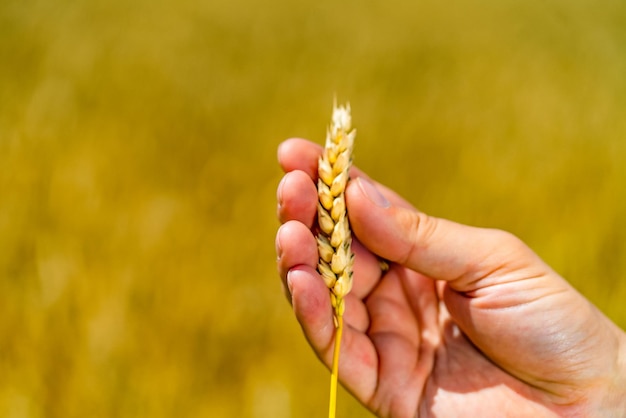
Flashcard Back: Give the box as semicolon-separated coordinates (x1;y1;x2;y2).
346;177;538;291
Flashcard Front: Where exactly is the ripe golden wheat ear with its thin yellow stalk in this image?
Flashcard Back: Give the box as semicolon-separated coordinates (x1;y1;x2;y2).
317;104;356;418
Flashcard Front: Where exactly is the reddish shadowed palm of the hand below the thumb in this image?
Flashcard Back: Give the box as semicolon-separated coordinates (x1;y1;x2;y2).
343;265;560;417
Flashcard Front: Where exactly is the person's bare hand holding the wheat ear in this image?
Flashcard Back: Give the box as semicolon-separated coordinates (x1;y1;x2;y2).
276;139;626;418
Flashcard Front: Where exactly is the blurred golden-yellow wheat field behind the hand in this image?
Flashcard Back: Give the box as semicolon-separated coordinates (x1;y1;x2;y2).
0;0;626;418
